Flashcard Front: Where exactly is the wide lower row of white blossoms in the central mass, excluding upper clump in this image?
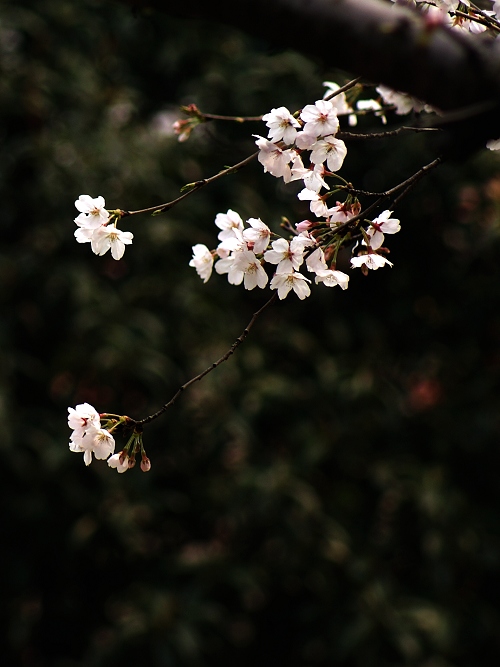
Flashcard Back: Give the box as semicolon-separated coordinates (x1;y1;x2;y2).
189;202;400;299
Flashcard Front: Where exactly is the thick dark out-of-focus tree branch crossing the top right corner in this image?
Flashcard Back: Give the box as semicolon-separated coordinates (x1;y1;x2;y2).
113;0;500;116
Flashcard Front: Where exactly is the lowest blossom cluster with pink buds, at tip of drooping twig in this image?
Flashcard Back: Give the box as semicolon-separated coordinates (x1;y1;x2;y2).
68;403;151;472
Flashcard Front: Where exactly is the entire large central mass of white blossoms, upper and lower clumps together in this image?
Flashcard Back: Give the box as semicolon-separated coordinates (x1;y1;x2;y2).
189;81;400;299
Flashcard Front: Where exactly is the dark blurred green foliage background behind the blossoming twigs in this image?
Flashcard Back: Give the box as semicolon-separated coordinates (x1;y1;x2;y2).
0;0;500;667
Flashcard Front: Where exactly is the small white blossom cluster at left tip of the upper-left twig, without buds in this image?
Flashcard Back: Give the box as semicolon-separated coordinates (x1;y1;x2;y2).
75;195;133;259
